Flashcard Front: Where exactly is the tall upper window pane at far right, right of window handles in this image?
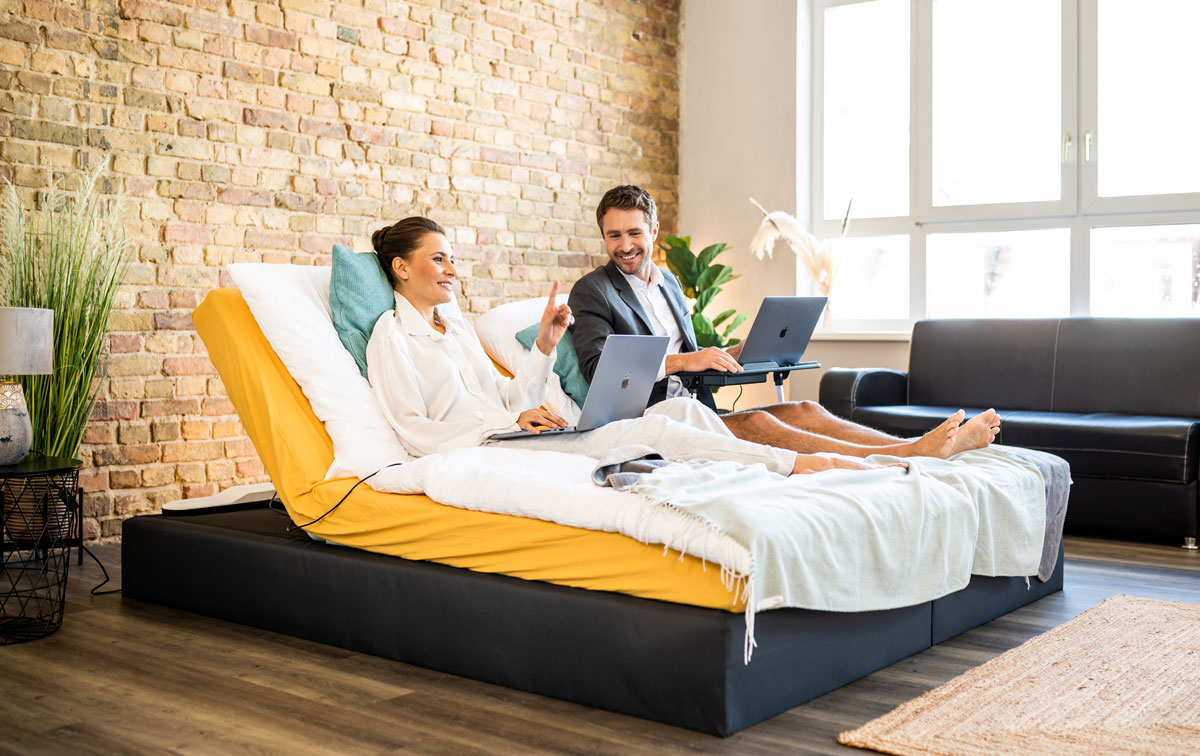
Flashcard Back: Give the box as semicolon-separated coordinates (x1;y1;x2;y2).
1096;0;1200;197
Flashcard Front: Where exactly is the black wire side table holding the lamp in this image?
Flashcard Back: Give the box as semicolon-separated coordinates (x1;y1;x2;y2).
0;455;83;646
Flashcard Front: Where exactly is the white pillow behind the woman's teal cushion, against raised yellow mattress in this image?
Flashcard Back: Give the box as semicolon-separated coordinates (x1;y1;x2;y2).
228;263;417;479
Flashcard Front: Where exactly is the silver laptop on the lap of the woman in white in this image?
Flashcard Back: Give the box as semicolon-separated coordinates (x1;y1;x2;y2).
490;334;670;440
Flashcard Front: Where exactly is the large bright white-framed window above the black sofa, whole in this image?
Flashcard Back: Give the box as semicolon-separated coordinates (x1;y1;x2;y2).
798;0;1200;331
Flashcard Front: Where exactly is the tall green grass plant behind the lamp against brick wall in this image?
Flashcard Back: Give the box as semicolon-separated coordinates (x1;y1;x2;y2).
0;163;127;457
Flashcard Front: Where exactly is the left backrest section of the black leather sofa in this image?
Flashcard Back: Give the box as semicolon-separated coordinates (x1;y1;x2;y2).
908;318;1058;409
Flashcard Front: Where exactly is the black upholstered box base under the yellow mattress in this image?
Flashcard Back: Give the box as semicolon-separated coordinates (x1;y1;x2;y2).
121;508;1062;736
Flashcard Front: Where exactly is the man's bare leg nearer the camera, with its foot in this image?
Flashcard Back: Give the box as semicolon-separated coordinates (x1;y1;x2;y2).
721;410;962;460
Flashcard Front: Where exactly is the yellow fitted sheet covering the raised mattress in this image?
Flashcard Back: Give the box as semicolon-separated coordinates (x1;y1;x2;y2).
192;288;745;611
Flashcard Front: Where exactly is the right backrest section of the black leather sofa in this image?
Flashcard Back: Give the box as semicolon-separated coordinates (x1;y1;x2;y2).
1056;318;1200;418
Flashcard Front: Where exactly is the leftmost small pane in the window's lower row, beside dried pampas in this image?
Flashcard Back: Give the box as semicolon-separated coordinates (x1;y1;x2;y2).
828;235;908;322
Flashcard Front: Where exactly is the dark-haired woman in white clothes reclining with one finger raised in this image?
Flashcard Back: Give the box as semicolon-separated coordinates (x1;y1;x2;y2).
367;217;883;475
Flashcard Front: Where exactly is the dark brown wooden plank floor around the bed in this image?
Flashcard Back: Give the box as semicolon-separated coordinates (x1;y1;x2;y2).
0;538;1200;756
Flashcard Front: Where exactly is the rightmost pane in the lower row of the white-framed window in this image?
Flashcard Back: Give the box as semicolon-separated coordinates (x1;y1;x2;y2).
1091;226;1200;318
